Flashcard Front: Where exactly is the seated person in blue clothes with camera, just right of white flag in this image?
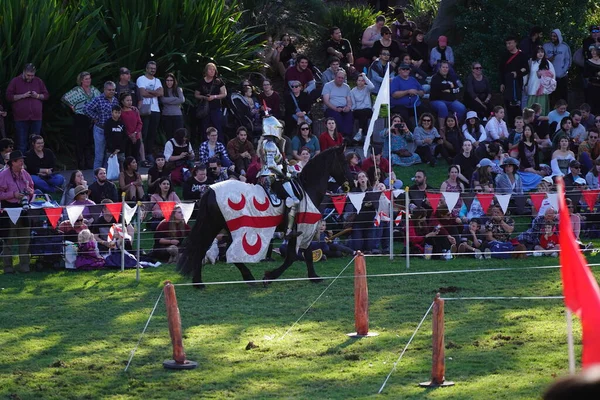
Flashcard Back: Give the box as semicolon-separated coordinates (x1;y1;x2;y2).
381;114;421;167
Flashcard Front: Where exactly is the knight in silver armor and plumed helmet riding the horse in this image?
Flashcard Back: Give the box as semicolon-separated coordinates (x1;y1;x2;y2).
257;116;302;239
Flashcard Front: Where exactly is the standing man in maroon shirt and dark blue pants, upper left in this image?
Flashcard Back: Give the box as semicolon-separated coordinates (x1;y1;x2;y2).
6;64;50;153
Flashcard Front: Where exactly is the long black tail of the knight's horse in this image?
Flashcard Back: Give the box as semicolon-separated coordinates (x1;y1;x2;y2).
177;188;215;277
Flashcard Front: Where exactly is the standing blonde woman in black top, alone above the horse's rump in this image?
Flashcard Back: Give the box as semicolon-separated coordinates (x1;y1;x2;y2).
194;63;227;141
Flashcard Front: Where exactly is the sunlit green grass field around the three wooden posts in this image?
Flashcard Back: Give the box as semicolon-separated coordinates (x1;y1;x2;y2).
0;252;600;399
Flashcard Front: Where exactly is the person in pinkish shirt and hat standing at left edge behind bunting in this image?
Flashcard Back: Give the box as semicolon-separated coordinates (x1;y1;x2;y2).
0;150;33;274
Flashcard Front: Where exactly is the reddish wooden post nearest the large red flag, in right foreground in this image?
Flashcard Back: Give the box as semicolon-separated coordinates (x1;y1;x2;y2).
419;293;454;387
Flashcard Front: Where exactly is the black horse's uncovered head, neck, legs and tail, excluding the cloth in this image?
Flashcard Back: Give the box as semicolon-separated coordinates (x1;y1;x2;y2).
177;146;353;288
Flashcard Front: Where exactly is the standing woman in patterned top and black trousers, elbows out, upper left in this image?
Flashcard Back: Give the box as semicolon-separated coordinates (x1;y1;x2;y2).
61;71;101;169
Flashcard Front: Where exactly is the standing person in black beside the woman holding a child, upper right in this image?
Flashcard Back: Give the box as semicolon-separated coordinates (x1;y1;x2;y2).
498;36;529;124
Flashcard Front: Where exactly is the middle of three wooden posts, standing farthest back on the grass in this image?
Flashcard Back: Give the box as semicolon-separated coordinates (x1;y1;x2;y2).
348;251;378;337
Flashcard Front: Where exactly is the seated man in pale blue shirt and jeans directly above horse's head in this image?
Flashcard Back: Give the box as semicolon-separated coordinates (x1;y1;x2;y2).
323;70;354;140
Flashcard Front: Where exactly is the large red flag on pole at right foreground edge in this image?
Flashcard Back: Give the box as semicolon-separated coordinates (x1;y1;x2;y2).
558;178;600;368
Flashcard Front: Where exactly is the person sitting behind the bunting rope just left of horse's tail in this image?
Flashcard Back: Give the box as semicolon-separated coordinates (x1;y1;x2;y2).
152;207;191;264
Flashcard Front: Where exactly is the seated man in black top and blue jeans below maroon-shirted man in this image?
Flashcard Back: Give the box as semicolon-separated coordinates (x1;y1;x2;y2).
25;135;65;193
